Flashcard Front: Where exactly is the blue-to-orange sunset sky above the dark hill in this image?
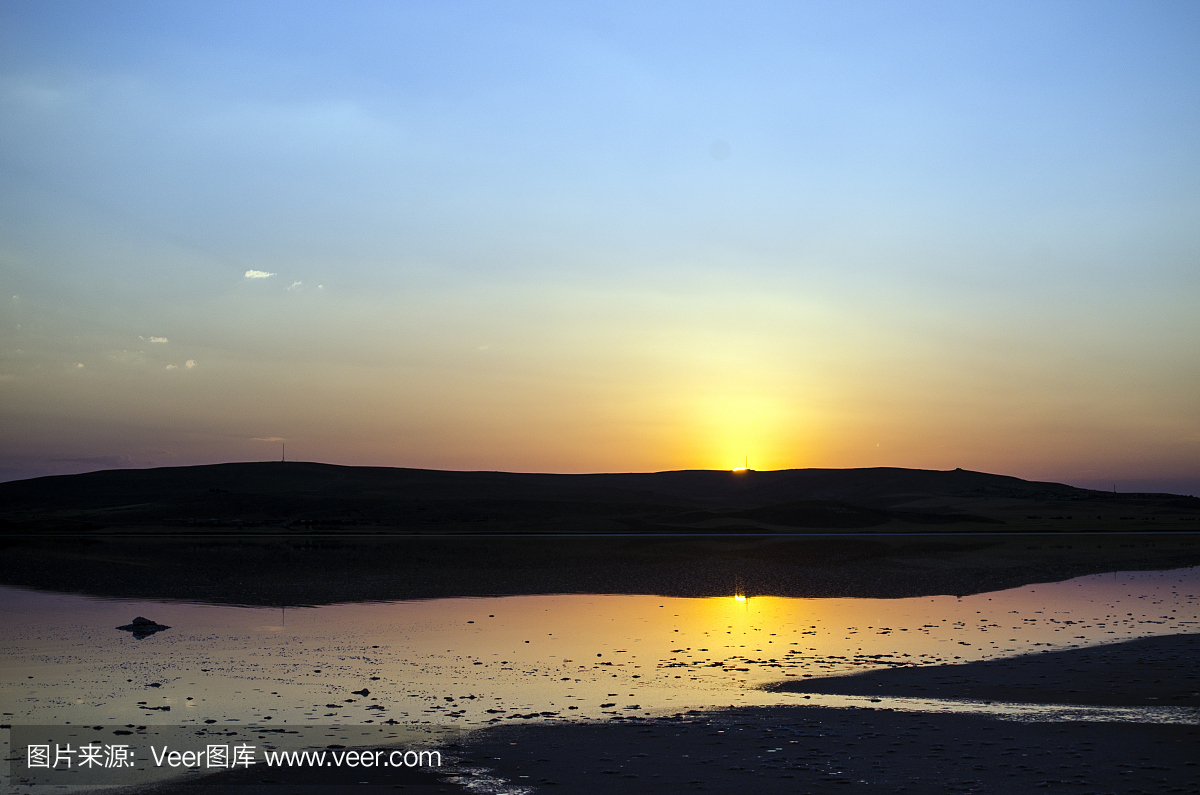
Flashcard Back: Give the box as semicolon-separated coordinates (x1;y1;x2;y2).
0;0;1200;495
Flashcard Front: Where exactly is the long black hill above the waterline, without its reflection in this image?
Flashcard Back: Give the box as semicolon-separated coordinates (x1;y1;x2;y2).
0;462;1200;534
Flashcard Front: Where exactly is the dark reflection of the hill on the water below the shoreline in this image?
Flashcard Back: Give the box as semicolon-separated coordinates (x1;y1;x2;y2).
0;533;1200;606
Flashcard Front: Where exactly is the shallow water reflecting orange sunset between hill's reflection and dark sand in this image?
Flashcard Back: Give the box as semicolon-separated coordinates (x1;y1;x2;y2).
0;568;1200;728
